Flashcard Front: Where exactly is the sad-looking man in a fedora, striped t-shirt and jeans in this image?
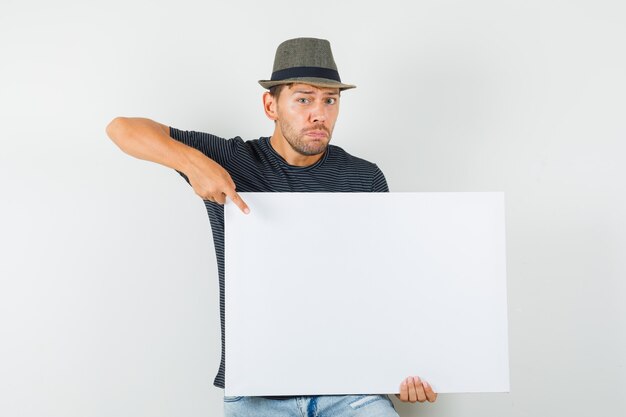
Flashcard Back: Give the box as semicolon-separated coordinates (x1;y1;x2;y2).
107;38;437;416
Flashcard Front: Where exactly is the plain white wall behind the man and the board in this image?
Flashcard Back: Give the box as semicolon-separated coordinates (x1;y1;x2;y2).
0;0;626;417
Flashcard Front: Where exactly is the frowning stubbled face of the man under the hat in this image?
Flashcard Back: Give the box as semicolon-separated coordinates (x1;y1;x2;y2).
276;84;339;156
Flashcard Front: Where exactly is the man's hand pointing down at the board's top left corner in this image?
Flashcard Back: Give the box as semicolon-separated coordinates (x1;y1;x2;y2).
185;148;250;214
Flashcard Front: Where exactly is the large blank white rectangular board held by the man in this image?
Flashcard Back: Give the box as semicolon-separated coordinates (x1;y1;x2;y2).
225;193;509;395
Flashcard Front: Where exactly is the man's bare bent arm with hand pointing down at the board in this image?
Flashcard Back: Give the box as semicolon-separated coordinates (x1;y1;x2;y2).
106;117;250;213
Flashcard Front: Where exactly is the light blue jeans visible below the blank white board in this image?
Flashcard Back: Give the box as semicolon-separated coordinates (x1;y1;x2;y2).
224;395;398;417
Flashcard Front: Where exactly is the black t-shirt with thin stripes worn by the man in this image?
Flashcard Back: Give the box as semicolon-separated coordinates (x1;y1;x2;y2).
170;127;389;388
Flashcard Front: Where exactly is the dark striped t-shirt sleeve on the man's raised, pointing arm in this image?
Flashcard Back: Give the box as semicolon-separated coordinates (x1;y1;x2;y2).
170;127;243;182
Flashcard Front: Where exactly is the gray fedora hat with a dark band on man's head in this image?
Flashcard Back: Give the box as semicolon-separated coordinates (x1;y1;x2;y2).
259;38;356;90
